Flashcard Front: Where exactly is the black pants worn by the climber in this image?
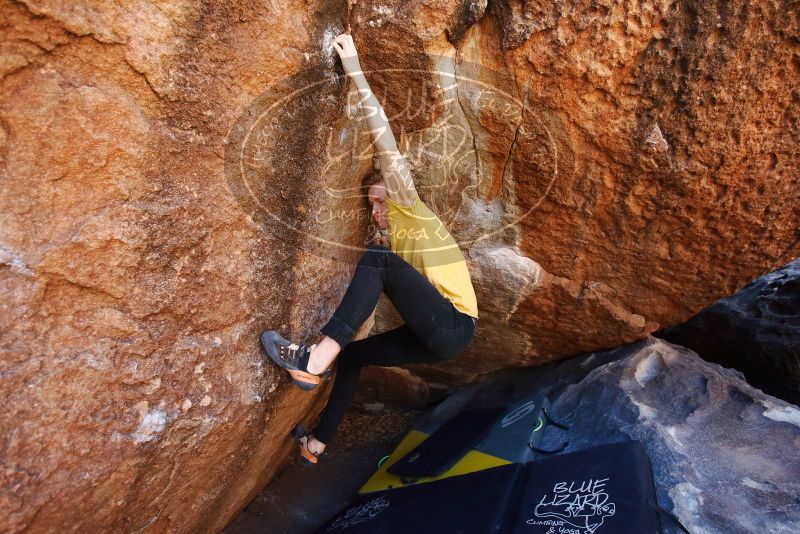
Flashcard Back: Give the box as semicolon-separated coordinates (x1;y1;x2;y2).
314;245;475;444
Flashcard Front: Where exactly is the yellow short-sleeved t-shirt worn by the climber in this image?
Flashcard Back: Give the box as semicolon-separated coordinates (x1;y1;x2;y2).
386;195;478;318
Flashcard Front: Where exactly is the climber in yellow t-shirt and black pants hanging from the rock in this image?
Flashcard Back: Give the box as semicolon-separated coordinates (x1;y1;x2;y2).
261;33;478;463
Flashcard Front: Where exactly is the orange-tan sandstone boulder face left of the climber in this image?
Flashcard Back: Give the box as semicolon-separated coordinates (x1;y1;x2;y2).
0;1;365;532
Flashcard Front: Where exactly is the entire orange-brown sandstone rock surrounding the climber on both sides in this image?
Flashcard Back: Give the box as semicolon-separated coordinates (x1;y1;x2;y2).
0;0;800;532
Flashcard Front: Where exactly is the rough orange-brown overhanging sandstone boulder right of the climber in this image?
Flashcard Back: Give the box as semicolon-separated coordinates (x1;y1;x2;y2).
364;1;800;388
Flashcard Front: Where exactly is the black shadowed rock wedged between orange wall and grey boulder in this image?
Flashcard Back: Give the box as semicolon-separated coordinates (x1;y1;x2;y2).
658;260;800;404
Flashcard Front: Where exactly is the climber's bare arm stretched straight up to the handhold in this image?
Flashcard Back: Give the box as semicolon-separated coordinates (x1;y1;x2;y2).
333;33;417;205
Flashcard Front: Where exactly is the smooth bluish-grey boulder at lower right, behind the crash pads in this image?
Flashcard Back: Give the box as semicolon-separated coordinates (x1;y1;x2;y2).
437;338;800;534
